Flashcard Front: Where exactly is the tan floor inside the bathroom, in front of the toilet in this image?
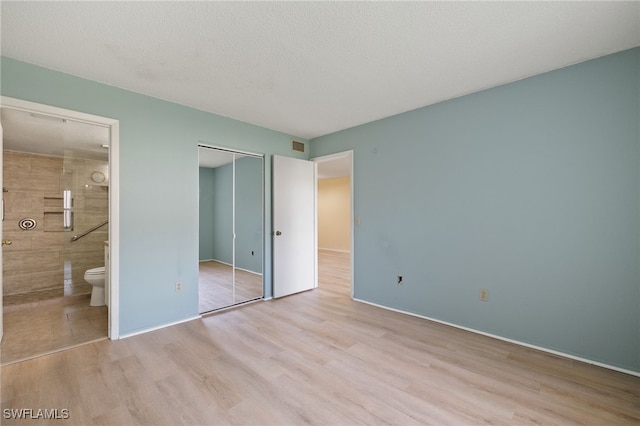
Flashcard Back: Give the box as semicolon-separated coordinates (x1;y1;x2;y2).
0;295;108;365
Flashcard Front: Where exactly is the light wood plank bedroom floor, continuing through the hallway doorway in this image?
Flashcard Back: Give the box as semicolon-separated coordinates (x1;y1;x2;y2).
2;253;640;425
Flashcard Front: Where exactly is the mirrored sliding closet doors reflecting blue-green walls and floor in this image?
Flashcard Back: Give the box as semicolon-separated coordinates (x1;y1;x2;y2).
198;145;264;313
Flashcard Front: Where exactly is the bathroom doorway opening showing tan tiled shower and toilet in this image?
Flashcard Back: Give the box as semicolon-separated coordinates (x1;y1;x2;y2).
0;97;117;365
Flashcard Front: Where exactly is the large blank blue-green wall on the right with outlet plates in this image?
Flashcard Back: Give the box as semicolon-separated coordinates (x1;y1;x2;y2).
310;49;640;371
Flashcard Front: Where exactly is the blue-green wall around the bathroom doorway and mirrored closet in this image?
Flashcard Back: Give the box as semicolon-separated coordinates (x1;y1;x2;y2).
0;57;305;334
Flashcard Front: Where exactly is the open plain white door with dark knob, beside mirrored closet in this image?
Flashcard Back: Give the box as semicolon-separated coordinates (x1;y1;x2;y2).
273;155;318;297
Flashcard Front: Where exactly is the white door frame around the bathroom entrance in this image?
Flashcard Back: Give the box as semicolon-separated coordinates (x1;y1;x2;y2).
0;96;120;340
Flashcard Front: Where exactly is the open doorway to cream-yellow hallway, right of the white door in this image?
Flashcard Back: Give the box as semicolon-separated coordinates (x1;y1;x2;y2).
312;151;355;298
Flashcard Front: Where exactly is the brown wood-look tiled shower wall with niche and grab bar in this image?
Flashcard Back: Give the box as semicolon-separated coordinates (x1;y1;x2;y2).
2;150;108;305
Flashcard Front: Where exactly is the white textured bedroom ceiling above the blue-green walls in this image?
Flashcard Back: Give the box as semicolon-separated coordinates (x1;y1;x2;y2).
0;0;640;138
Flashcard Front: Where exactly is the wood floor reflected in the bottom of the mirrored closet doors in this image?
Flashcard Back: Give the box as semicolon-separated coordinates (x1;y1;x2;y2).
198;260;262;313
